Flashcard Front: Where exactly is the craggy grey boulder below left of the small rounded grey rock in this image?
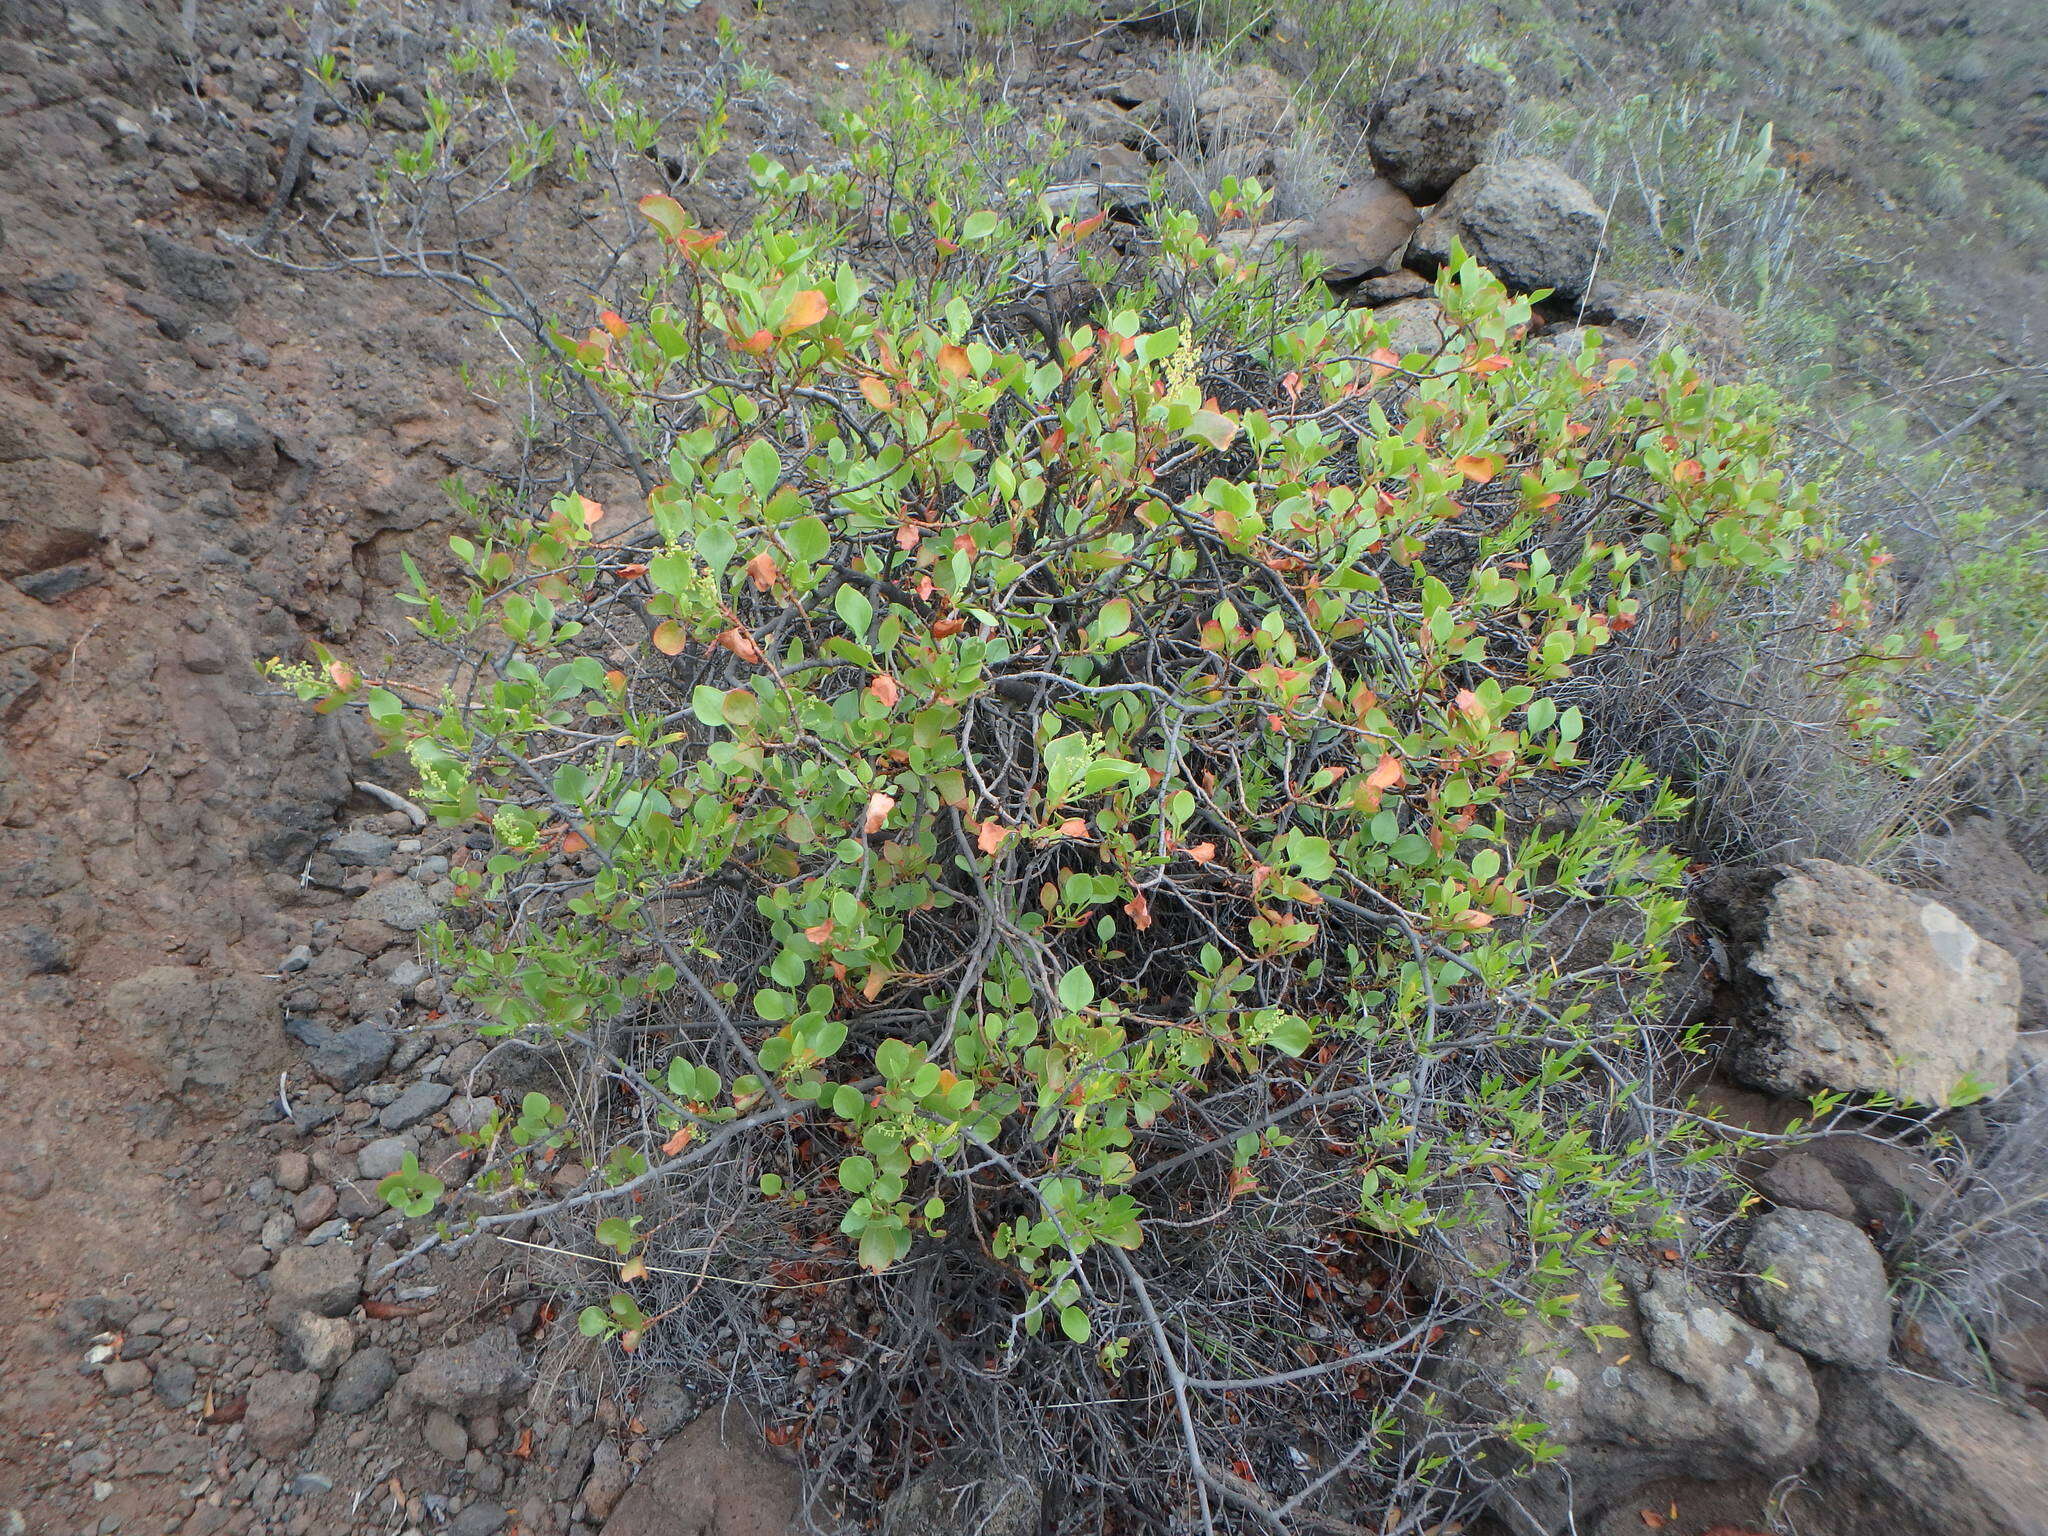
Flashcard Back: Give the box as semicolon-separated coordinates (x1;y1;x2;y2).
1444;1272;1821;1536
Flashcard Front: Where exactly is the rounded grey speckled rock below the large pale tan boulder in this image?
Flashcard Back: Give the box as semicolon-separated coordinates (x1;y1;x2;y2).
1743;1210;1892;1366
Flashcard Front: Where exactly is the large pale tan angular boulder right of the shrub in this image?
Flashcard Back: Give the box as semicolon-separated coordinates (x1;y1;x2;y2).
1700;858;2019;1104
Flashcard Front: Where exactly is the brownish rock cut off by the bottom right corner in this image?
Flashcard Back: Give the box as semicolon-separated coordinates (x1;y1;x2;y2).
1812;1370;2048;1536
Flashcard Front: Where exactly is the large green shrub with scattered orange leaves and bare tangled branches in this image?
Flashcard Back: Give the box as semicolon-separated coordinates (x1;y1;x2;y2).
284;51;1917;1530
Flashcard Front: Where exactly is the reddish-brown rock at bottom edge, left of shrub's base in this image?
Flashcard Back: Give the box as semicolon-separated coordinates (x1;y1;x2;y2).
604;1411;798;1536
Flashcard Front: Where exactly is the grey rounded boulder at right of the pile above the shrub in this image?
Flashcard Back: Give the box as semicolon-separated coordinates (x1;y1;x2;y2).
1409;156;1608;303
